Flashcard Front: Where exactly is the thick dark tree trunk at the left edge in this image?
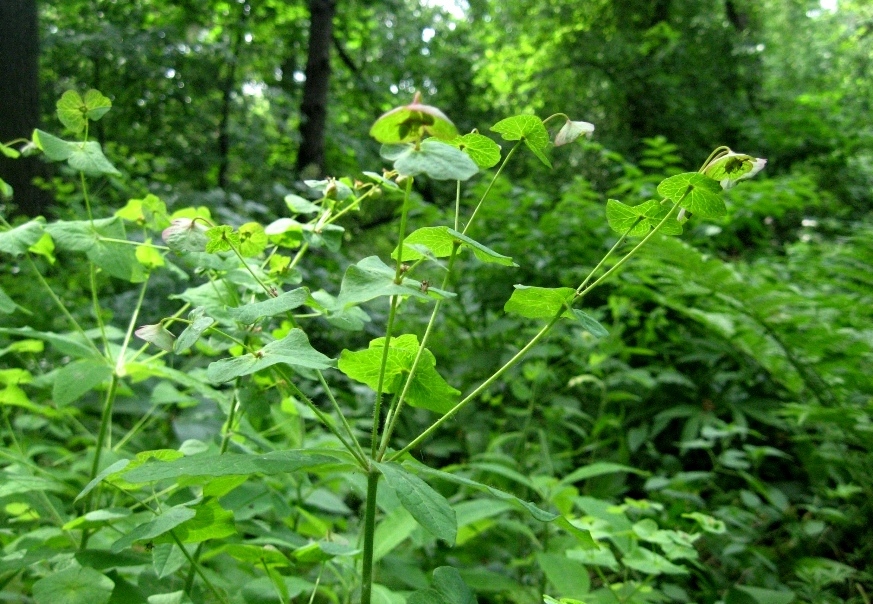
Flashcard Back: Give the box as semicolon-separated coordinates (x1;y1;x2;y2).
0;0;51;216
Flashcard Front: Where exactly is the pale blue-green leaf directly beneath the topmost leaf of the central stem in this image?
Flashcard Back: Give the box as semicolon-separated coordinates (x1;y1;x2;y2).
379;139;479;180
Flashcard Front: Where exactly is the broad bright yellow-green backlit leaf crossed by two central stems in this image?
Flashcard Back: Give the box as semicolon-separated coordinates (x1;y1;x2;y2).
338;334;461;414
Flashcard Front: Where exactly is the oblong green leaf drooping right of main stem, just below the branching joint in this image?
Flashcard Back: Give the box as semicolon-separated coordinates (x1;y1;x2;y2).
373;463;458;545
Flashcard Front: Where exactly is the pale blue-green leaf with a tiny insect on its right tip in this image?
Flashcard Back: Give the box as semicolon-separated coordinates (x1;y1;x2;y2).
337;256;455;306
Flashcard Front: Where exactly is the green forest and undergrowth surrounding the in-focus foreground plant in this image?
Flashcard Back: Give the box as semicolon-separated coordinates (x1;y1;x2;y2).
0;0;873;604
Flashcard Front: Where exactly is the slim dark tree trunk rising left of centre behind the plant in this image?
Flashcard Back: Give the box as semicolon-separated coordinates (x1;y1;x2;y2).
297;0;336;176
